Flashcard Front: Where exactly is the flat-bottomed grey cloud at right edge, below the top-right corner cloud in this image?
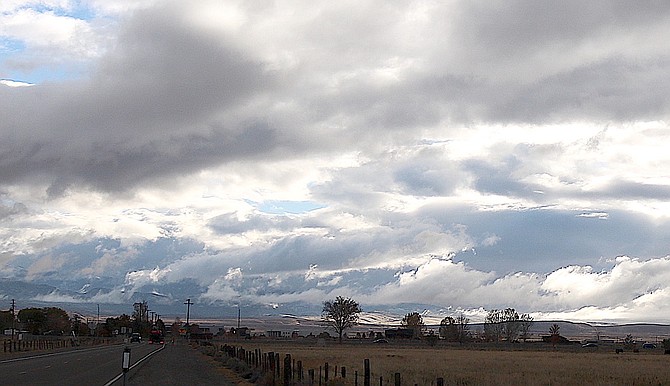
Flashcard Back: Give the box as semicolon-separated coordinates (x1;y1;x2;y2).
489;57;670;122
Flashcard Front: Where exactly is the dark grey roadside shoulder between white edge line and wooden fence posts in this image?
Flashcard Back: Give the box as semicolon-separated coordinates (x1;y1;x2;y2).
126;341;242;386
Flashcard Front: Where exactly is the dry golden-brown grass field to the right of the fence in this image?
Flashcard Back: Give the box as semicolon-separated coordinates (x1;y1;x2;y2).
235;340;670;385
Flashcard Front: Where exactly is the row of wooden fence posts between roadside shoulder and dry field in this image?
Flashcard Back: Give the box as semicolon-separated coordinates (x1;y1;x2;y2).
218;345;444;386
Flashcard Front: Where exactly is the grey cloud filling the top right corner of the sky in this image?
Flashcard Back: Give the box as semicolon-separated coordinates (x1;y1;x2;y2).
453;0;670;58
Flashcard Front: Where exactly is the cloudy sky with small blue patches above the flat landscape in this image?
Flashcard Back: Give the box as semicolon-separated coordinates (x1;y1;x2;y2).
0;0;670;322
